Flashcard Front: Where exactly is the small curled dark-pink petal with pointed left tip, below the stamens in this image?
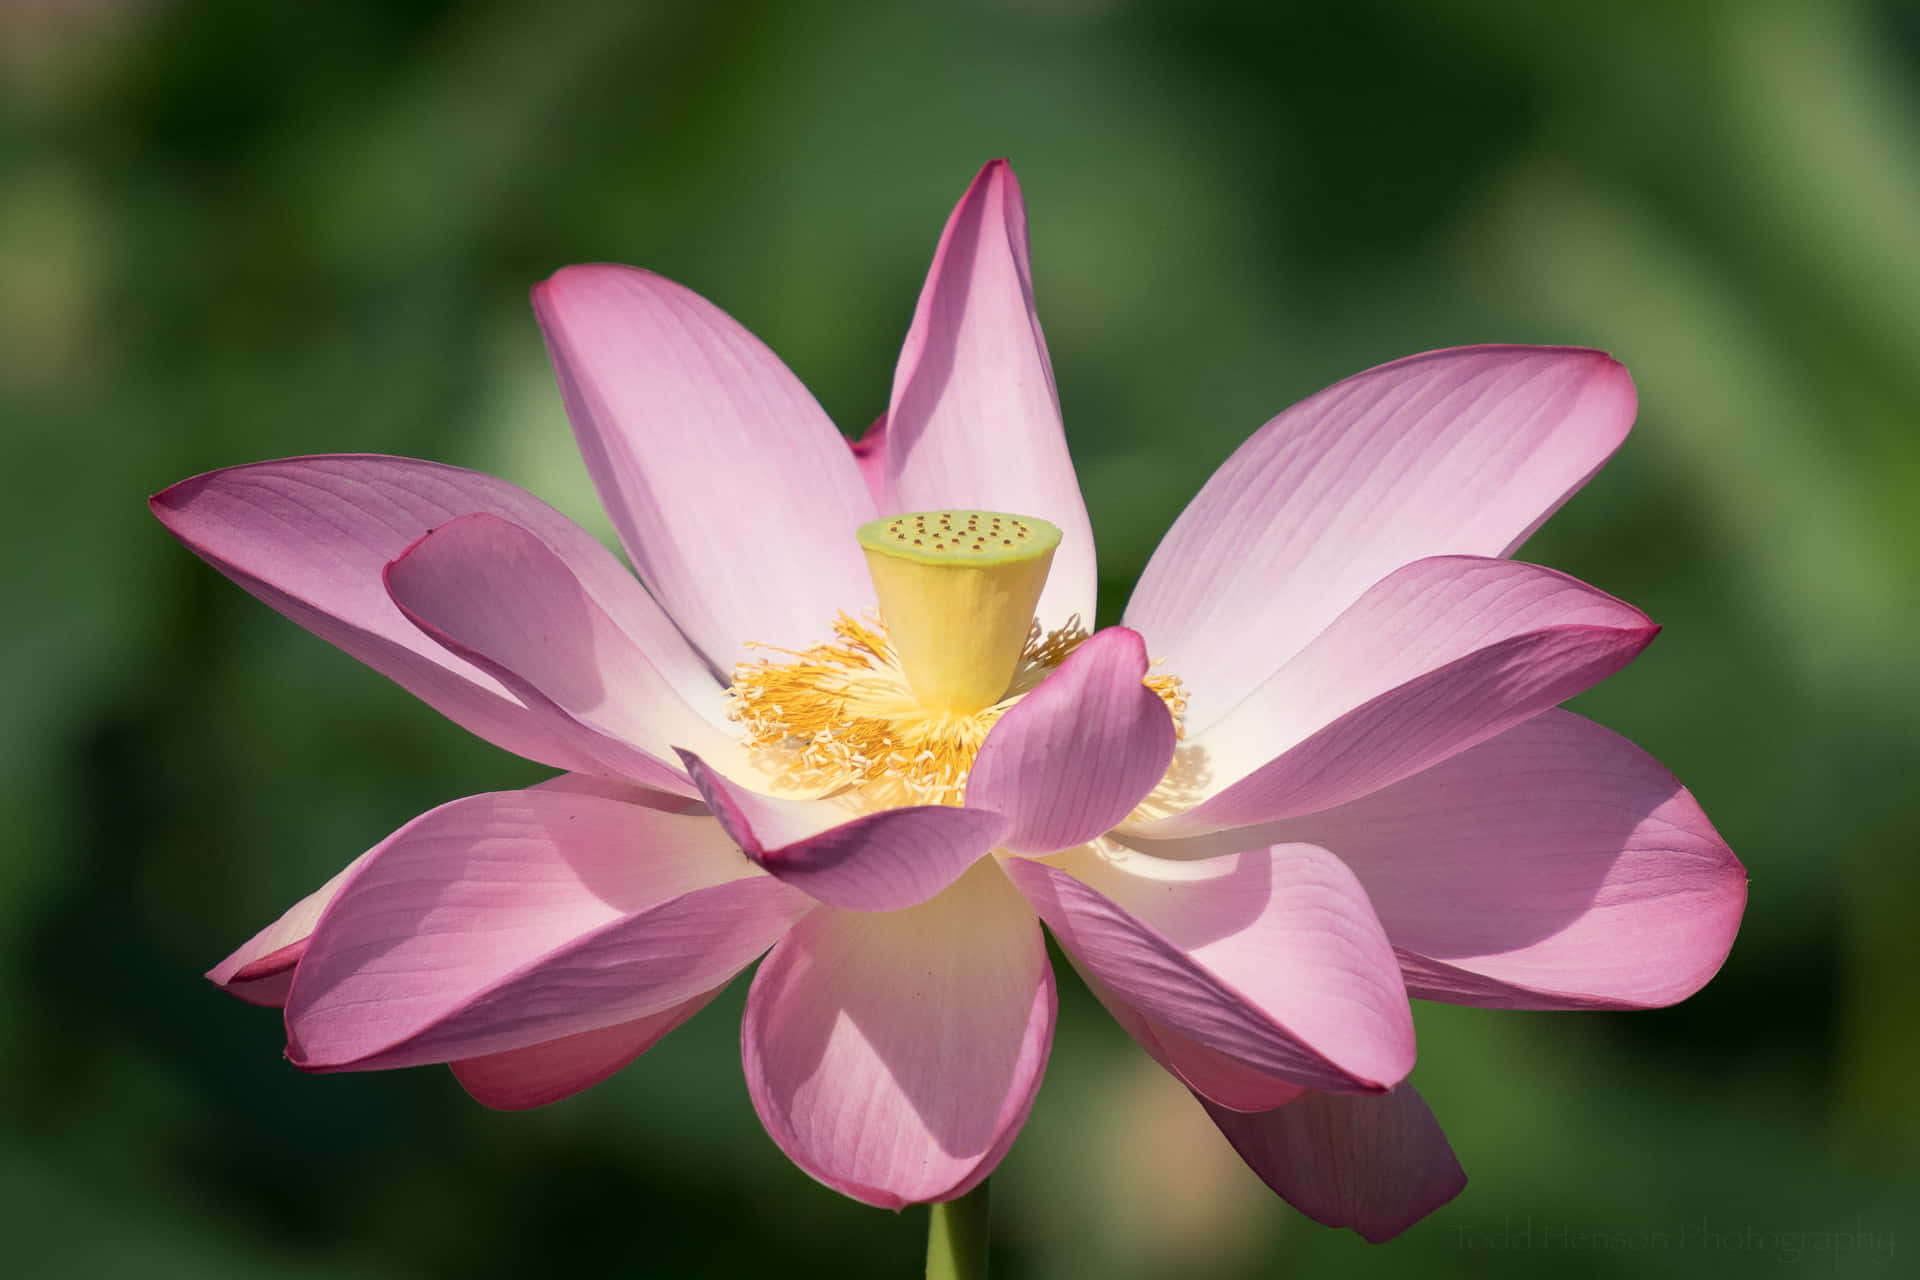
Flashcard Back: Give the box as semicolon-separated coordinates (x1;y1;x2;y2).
682;752;1006;912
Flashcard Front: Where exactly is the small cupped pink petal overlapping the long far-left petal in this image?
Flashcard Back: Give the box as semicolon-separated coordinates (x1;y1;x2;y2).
386;514;752;791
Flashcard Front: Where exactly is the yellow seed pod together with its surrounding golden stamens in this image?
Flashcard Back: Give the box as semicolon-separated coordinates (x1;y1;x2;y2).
728;510;1187;810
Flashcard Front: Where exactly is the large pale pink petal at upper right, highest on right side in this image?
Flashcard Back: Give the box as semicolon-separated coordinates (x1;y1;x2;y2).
1125;347;1636;731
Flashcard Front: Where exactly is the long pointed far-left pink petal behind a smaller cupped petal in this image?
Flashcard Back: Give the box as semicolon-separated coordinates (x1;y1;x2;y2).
150;455;720;768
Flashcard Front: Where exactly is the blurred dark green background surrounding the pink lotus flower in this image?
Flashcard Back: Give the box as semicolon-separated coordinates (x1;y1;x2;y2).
0;0;1920;1280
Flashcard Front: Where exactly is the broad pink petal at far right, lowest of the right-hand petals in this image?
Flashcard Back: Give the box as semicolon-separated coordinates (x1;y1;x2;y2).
1261;712;1747;1009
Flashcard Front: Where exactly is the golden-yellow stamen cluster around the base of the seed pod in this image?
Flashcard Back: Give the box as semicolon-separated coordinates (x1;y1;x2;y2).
728;614;1187;810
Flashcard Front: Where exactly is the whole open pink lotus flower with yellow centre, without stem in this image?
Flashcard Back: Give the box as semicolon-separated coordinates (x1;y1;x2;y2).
152;163;1745;1240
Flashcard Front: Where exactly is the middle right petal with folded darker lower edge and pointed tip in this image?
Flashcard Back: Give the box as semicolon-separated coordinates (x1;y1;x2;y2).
1137;557;1659;836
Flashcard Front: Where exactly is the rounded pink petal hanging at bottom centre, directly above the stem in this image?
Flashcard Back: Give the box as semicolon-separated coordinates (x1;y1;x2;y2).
741;864;1054;1209
